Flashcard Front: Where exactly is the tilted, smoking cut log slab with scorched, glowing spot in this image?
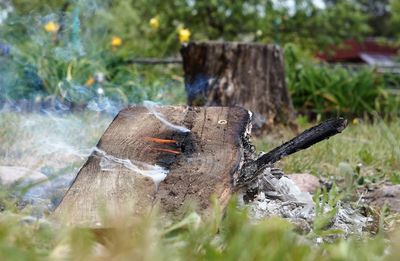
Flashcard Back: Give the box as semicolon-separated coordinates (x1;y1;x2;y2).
56;106;250;227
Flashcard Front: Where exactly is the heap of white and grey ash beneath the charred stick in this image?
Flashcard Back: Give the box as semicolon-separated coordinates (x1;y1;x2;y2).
242;167;371;236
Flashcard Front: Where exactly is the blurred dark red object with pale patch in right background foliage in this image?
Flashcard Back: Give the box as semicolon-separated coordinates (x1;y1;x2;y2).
316;39;400;66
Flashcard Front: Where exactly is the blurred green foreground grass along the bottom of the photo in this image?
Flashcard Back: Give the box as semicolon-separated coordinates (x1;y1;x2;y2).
0;196;399;260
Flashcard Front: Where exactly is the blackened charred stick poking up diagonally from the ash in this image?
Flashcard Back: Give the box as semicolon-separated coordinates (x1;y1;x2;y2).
235;118;347;187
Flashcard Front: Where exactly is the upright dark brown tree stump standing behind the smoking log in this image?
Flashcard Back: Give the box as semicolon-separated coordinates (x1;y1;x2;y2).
181;42;294;133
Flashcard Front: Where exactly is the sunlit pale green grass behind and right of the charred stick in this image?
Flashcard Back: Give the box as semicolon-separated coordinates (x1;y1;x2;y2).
255;119;400;187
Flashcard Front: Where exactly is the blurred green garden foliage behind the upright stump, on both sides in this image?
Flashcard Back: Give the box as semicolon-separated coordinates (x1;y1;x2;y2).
0;0;399;107
